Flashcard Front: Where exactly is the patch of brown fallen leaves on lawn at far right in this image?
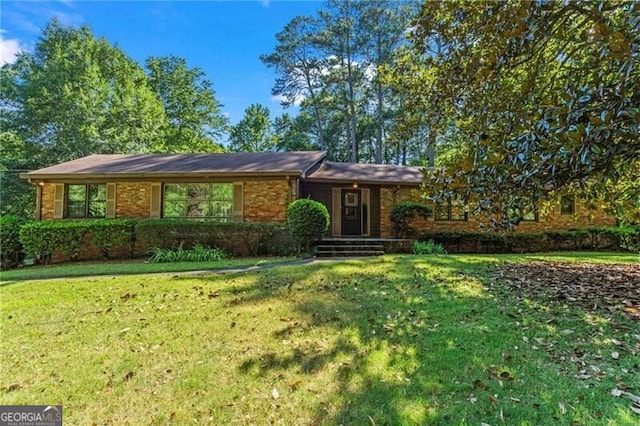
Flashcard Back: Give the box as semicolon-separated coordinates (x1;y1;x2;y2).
497;262;640;321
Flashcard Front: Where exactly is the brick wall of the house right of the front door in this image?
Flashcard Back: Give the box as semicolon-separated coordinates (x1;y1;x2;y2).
380;188;616;238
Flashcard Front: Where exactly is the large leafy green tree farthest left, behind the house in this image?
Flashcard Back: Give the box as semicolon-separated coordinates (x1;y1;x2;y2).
1;20;164;165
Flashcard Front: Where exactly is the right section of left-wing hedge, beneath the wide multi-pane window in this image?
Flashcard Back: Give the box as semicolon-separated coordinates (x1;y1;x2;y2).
135;219;292;256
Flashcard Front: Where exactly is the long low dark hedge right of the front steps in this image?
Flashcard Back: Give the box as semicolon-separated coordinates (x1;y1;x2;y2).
420;227;640;253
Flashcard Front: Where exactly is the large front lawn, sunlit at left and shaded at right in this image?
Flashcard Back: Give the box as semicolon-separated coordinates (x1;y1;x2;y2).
0;254;640;425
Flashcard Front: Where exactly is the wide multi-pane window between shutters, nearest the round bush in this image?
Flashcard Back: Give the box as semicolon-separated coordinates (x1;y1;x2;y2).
162;183;233;222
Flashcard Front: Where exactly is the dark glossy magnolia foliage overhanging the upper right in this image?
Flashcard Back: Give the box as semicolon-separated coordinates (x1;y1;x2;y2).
387;1;640;226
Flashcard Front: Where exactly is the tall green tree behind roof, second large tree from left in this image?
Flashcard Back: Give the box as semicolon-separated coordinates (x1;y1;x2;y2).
146;56;228;152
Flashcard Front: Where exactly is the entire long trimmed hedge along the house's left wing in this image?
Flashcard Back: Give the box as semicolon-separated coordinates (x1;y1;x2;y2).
20;219;293;263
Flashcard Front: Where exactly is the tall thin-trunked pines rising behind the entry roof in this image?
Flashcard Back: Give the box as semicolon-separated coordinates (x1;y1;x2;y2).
261;0;416;162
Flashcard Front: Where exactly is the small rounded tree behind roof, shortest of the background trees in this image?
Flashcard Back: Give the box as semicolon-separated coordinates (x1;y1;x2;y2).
229;104;276;152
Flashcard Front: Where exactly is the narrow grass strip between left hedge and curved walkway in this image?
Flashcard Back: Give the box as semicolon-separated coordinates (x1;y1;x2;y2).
0;257;293;282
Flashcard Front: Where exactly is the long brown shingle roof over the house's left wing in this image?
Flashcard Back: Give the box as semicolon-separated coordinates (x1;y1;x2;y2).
21;151;326;179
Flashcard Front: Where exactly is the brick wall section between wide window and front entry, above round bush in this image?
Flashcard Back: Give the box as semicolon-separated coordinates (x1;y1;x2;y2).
243;179;297;222
